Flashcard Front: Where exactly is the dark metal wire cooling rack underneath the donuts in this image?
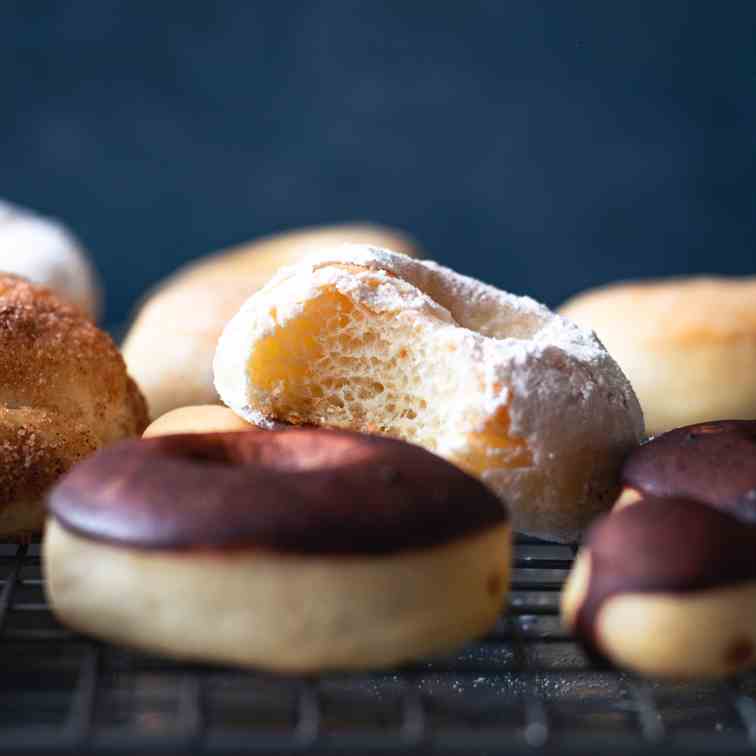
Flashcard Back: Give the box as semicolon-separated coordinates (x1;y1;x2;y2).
0;540;756;756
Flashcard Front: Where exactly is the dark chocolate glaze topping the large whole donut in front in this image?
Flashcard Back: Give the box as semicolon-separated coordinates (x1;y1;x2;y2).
49;429;508;554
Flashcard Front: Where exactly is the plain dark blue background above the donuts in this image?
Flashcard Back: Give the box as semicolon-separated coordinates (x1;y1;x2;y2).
0;0;756;320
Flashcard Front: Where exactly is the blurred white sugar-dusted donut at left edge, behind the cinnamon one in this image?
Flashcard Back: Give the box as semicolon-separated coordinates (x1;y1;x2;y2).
0;200;102;318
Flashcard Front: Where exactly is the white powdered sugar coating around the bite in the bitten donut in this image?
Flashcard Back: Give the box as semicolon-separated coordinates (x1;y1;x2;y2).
215;245;643;541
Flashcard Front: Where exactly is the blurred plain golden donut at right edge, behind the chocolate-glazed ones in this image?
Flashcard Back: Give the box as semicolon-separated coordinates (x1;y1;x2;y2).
559;276;756;434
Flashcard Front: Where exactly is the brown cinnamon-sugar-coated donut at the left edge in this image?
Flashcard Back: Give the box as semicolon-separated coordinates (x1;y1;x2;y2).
0;274;147;538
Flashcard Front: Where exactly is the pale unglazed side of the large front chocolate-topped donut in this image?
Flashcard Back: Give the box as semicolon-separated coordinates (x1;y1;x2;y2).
43;521;509;673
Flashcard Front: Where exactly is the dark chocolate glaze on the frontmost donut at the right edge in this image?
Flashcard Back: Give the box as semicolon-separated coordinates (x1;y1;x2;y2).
576;497;756;660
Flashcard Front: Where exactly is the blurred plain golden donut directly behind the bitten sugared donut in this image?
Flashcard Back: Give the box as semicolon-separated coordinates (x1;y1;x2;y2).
123;223;417;419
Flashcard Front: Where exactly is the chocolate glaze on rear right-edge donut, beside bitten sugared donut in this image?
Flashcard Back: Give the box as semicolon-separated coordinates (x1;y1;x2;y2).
622;420;756;522
